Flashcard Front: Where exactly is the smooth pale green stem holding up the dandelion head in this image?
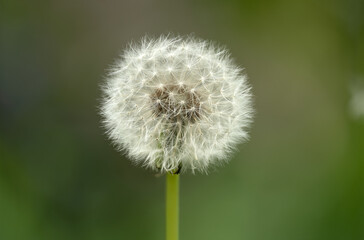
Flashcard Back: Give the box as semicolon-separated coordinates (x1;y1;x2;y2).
166;173;179;240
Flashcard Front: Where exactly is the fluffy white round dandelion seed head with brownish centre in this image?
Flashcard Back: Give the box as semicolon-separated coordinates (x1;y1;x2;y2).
101;37;253;172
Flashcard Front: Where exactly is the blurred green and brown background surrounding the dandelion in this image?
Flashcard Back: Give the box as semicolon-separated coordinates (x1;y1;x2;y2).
0;0;364;240
